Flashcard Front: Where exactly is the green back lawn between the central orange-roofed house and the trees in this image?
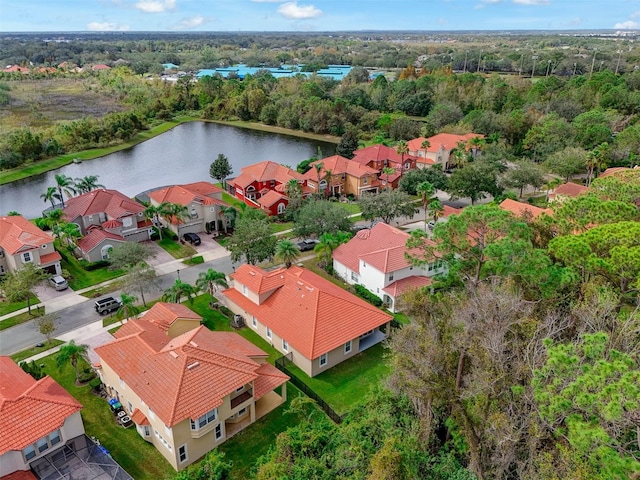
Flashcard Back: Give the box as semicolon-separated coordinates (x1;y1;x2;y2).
287;343;390;415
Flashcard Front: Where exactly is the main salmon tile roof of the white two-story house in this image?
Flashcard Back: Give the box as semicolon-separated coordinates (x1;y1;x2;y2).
332;222;436;273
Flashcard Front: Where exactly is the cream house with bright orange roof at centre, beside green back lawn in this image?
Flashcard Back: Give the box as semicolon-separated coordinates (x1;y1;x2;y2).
222;264;393;377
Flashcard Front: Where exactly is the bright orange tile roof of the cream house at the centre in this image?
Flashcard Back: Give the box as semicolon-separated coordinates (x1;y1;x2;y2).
223;265;393;359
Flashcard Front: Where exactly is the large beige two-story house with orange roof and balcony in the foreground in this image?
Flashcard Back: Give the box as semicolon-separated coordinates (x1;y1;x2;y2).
94;317;289;471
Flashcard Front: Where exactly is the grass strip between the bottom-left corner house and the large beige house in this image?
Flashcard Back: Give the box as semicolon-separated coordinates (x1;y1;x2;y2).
21;354;175;480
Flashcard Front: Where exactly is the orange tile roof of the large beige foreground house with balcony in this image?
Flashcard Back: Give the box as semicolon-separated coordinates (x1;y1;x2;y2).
95;319;289;427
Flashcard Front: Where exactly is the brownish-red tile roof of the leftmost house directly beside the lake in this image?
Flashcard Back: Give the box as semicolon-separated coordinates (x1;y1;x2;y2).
63;189;145;221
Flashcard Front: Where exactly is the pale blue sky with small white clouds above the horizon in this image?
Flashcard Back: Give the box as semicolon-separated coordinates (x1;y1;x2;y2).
0;0;640;32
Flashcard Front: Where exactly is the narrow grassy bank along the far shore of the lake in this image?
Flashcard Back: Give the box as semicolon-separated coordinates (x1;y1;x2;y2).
0;116;340;185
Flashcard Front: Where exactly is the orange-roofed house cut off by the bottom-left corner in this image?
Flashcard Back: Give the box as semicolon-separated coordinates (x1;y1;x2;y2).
0;357;85;479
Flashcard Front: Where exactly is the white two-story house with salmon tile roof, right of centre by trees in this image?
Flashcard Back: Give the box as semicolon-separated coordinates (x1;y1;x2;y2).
332;222;446;312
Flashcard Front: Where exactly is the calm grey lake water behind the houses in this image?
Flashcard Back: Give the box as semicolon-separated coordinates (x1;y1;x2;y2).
0;122;335;218
